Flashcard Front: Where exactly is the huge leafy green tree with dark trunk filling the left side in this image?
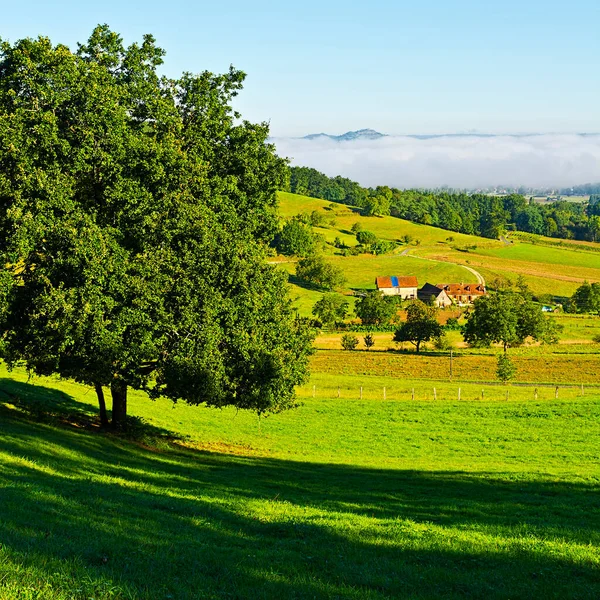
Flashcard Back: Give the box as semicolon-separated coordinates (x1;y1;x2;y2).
0;26;310;427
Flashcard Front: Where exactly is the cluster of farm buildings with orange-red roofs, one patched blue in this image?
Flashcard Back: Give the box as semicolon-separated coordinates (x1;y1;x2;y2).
375;275;486;308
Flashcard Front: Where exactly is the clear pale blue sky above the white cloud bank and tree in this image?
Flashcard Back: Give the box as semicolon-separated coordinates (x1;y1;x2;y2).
0;0;600;136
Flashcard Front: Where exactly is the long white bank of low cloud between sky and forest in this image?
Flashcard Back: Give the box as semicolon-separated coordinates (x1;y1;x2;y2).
272;134;600;189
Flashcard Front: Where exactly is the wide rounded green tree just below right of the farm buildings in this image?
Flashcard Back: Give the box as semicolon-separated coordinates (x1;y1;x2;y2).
464;292;559;352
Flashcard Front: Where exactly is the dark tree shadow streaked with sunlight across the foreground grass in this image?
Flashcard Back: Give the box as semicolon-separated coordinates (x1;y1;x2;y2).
0;382;600;600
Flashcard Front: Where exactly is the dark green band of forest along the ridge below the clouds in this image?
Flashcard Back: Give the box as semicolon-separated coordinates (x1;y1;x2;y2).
288;167;600;241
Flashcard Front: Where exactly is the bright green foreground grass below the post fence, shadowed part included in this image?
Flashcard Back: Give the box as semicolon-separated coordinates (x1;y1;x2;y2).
0;364;600;600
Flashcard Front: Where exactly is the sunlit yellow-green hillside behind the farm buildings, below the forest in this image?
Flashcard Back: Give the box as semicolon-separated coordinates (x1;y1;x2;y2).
279;193;600;304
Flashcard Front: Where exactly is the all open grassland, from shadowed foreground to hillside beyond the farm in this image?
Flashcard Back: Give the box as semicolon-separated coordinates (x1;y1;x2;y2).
0;194;600;600
